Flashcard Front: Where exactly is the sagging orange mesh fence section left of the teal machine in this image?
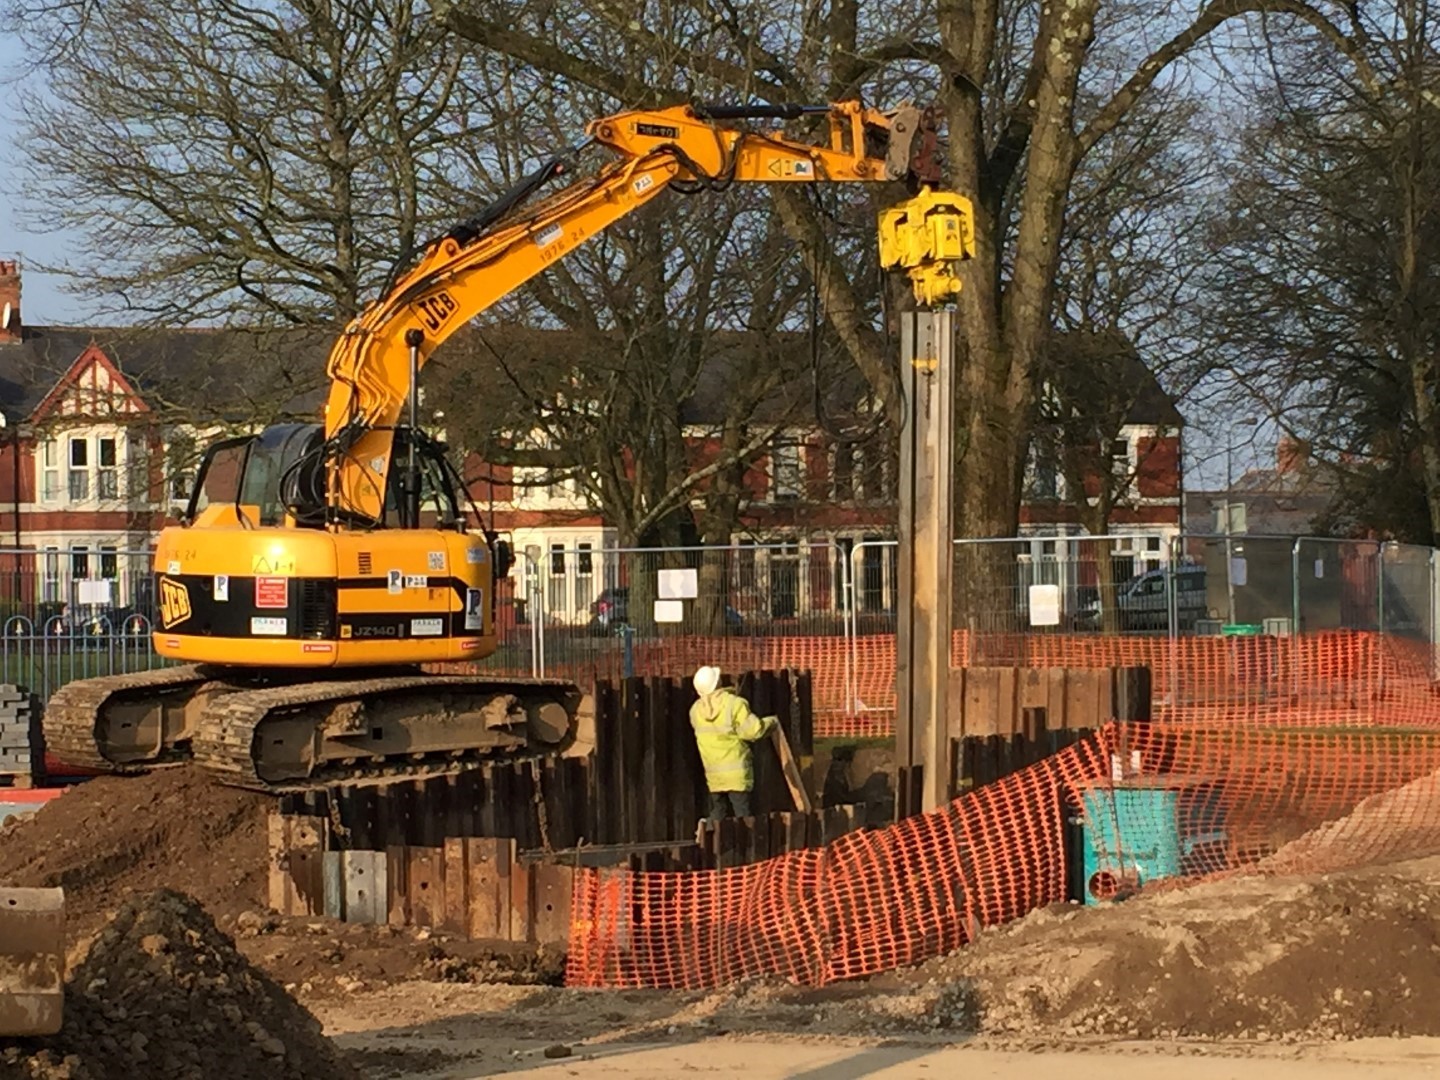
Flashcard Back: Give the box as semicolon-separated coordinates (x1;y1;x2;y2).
566;736;1107;988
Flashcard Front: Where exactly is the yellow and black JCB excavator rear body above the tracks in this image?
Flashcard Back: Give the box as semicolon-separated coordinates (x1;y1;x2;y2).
154;514;495;667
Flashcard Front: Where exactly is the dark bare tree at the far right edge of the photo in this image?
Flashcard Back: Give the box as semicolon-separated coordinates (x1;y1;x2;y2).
1210;0;1440;543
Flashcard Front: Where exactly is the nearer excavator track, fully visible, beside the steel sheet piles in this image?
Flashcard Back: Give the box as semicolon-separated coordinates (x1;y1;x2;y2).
192;674;585;792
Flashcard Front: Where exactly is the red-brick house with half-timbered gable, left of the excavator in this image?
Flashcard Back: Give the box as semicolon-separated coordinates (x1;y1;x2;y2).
0;261;328;616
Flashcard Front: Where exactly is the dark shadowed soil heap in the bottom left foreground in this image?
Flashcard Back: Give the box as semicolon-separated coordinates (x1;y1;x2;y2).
0;890;356;1080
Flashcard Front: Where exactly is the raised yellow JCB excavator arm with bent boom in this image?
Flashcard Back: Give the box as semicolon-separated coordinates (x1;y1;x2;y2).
325;102;937;527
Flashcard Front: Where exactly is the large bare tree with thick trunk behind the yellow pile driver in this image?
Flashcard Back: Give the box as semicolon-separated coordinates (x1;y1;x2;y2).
436;0;1428;536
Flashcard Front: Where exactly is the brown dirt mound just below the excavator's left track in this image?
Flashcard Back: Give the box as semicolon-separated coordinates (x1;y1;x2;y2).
0;766;274;932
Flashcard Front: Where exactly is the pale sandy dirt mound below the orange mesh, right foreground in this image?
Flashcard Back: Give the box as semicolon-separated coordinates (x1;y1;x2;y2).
901;858;1440;1040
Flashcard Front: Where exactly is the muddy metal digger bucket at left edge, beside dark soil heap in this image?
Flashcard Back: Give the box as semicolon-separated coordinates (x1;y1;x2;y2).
0;888;65;1035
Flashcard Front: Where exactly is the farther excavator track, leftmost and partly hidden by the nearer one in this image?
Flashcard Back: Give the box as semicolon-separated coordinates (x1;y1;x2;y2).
45;664;213;773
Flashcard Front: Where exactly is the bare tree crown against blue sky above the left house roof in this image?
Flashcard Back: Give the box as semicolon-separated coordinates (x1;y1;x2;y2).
9;0;485;327
